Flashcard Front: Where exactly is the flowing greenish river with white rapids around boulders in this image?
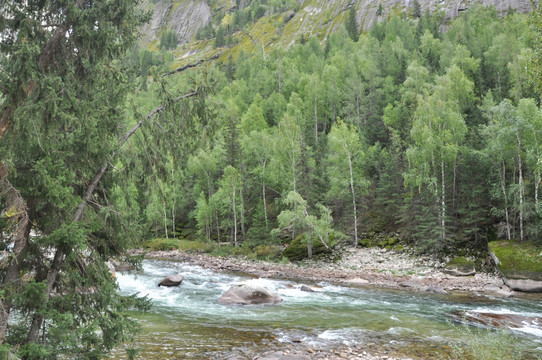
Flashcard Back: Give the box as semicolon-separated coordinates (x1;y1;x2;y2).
112;260;542;360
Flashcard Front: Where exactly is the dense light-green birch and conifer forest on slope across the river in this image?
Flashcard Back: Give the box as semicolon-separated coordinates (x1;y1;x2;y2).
126;6;542;253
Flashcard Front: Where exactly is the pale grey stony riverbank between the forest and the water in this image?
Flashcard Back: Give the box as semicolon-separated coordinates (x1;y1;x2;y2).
134;248;514;297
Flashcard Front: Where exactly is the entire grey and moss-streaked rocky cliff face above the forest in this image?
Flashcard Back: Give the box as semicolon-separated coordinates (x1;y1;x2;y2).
142;0;531;67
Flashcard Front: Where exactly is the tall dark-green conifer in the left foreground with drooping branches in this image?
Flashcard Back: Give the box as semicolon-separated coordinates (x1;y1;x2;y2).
0;0;160;359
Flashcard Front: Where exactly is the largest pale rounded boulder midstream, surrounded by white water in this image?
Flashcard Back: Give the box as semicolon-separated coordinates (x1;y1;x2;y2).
218;284;282;305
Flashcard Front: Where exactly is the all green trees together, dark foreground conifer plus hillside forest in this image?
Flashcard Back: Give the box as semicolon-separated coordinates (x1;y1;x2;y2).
0;0;542;359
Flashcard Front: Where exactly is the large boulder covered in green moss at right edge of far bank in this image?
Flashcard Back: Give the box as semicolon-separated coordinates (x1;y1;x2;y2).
489;241;542;281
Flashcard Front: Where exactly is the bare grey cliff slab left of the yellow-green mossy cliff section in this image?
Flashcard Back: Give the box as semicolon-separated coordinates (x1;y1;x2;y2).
142;0;211;45
